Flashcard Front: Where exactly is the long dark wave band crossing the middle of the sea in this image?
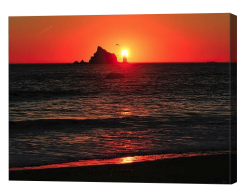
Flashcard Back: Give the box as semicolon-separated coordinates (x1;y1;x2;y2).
9;113;228;132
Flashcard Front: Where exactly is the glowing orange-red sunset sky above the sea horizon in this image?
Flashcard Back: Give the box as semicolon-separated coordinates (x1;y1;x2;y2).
8;13;237;63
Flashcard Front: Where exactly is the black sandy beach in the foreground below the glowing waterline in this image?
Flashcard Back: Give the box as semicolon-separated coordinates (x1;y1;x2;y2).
8;154;237;185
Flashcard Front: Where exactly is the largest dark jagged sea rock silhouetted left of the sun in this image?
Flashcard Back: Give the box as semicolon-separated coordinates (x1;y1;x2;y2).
89;46;118;64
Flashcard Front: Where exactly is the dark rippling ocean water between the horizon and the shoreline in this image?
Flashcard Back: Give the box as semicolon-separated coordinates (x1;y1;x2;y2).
8;63;237;167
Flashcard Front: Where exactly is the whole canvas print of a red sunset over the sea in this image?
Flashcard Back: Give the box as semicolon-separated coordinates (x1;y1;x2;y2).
8;12;237;185
